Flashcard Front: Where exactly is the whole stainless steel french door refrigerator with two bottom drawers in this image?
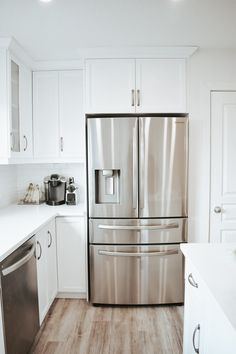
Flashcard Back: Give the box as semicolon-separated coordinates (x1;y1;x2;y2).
87;116;188;305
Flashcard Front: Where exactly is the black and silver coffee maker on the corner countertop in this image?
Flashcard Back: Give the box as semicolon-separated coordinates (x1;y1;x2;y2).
44;173;66;205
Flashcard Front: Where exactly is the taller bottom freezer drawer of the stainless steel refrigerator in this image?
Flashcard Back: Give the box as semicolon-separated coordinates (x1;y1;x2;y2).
90;244;184;305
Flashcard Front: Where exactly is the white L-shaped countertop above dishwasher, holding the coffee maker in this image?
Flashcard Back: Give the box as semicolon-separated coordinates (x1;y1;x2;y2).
0;204;85;262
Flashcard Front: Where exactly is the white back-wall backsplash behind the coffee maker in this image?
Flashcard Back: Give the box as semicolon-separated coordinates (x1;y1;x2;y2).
16;164;85;203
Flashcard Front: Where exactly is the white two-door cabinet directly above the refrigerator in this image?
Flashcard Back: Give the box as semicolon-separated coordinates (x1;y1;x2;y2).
85;59;187;113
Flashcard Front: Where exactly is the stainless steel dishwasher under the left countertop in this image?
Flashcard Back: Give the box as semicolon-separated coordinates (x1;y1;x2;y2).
1;236;39;354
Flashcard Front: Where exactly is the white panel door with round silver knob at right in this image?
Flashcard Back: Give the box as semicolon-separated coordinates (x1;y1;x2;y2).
210;92;236;242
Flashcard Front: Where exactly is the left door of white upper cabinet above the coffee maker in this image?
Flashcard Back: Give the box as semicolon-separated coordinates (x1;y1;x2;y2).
33;71;60;158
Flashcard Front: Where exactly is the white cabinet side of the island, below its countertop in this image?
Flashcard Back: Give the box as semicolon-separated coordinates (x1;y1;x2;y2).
183;261;236;354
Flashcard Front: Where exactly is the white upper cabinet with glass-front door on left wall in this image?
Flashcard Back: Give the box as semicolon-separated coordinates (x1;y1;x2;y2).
0;43;33;163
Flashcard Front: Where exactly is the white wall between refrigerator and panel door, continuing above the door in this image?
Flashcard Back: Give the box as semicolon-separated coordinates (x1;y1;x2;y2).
189;49;236;242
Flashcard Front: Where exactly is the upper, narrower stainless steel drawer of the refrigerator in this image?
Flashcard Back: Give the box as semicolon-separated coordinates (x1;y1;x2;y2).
89;218;187;244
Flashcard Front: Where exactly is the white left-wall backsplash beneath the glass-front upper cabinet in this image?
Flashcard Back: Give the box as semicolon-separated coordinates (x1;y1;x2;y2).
0;166;17;208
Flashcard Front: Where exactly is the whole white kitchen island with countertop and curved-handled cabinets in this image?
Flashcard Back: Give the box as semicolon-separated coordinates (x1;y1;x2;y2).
181;243;236;354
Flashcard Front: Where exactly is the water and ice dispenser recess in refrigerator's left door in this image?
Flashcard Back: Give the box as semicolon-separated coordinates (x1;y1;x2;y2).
95;169;120;204
